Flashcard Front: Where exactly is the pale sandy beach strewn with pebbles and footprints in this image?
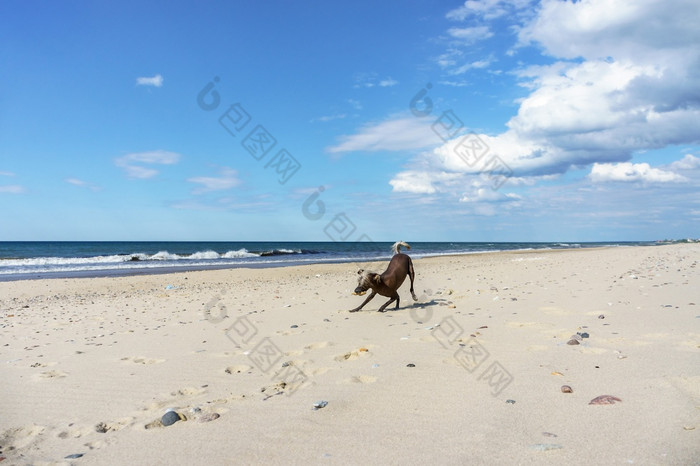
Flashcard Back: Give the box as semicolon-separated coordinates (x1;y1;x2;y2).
0;245;700;466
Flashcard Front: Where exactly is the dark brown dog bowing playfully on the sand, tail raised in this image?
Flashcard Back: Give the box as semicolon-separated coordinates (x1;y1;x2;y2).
350;241;418;312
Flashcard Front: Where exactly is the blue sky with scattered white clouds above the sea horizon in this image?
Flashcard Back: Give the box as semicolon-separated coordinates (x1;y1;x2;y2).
0;0;700;241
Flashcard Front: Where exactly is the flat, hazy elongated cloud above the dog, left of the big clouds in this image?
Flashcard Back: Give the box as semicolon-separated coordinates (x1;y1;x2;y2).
326;117;439;154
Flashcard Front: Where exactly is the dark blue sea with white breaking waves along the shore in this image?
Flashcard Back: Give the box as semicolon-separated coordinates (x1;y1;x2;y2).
0;241;654;281
